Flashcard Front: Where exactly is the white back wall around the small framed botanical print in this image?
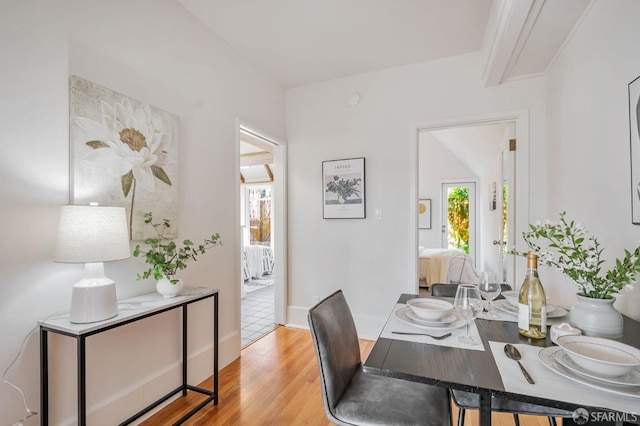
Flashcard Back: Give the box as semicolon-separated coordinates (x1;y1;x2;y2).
287;54;545;338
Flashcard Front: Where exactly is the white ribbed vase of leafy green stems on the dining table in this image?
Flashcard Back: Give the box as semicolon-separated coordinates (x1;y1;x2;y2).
512;212;640;338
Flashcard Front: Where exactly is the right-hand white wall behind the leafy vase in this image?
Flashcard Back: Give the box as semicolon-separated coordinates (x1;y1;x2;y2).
544;0;640;318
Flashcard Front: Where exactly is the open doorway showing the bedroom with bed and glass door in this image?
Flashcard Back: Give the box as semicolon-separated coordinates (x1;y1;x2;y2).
417;118;524;289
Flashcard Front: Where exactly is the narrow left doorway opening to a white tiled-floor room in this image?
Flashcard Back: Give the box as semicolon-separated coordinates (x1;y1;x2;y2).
238;124;286;347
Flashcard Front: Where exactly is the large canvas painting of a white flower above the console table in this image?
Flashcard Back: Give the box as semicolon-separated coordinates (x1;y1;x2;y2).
69;76;178;240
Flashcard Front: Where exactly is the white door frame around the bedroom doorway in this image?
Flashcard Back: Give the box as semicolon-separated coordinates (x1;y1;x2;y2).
408;109;530;294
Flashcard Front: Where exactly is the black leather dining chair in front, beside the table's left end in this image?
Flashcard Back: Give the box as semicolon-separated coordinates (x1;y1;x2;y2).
307;290;451;426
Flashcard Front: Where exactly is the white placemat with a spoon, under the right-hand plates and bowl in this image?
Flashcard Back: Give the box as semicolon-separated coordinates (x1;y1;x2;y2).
489;342;640;413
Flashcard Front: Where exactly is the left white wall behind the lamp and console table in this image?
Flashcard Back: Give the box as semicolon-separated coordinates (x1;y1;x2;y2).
0;0;284;425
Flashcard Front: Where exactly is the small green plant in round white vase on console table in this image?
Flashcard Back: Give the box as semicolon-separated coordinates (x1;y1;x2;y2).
133;212;222;297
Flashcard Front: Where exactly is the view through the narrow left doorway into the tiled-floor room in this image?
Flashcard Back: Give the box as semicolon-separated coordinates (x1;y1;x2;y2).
239;126;280;347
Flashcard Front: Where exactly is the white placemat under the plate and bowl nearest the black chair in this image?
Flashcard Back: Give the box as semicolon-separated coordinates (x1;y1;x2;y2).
380;303;484;351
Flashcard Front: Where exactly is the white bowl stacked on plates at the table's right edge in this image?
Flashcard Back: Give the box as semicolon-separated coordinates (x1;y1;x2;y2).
558;336;640;377
